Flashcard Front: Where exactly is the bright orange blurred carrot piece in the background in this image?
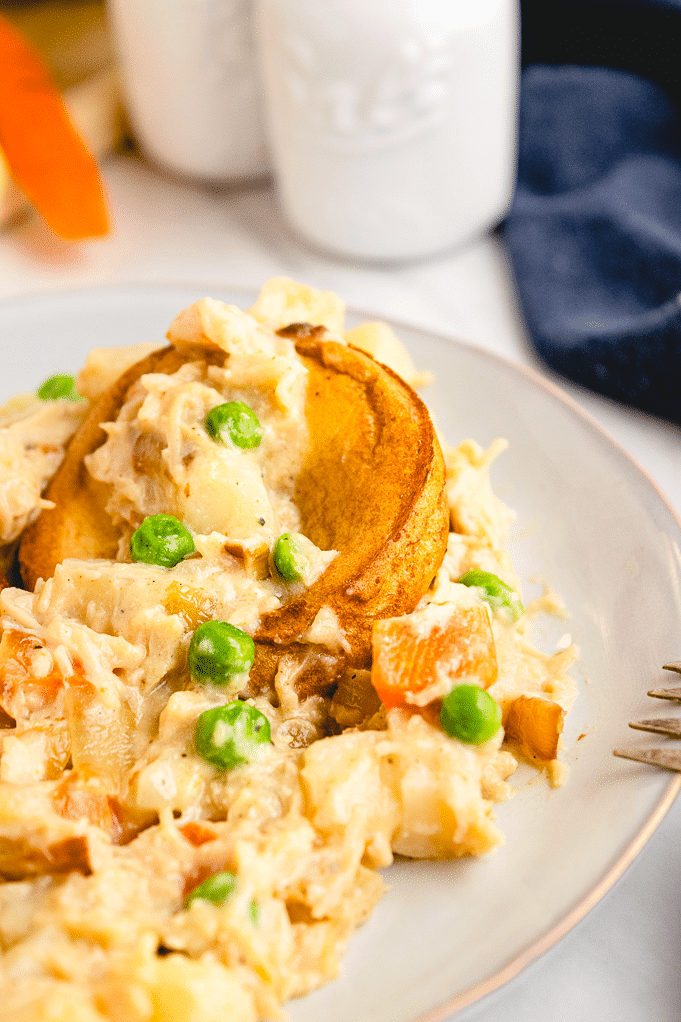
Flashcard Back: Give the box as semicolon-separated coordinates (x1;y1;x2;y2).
0;16;109;241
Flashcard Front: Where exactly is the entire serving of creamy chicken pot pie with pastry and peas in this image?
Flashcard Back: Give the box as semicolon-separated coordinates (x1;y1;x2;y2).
0;279;575;1022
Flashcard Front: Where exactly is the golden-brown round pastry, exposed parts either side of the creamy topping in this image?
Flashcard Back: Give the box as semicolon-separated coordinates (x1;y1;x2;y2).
19;324;448;694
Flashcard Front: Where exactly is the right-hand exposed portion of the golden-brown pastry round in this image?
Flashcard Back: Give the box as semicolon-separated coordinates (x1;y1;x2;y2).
260;326;449;664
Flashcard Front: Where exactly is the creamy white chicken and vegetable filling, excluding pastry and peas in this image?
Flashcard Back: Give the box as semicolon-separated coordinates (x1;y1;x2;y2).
0;282;575;1022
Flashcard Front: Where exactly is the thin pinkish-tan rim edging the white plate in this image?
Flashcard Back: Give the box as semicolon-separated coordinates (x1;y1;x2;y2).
0;280;681;1022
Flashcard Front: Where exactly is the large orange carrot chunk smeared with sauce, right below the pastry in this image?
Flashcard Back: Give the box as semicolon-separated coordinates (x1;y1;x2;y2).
371;605;497;708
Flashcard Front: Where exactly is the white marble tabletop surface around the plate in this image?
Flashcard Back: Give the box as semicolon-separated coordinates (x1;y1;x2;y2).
0;156;681;1022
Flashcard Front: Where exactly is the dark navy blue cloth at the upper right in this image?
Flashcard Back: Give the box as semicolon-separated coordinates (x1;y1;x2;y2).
501;0;681;422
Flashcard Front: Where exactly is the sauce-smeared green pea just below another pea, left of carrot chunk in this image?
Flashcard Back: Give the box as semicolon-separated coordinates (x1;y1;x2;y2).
194;699;272;771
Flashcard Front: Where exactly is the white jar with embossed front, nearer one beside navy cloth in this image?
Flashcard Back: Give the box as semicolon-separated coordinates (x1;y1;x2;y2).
257;0;518;261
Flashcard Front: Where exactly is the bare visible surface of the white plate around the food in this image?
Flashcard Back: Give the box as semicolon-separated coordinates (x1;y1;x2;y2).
0;286;681;1022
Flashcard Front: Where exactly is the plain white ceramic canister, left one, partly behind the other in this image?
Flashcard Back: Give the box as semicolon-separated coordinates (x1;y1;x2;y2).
107;0;270;183
